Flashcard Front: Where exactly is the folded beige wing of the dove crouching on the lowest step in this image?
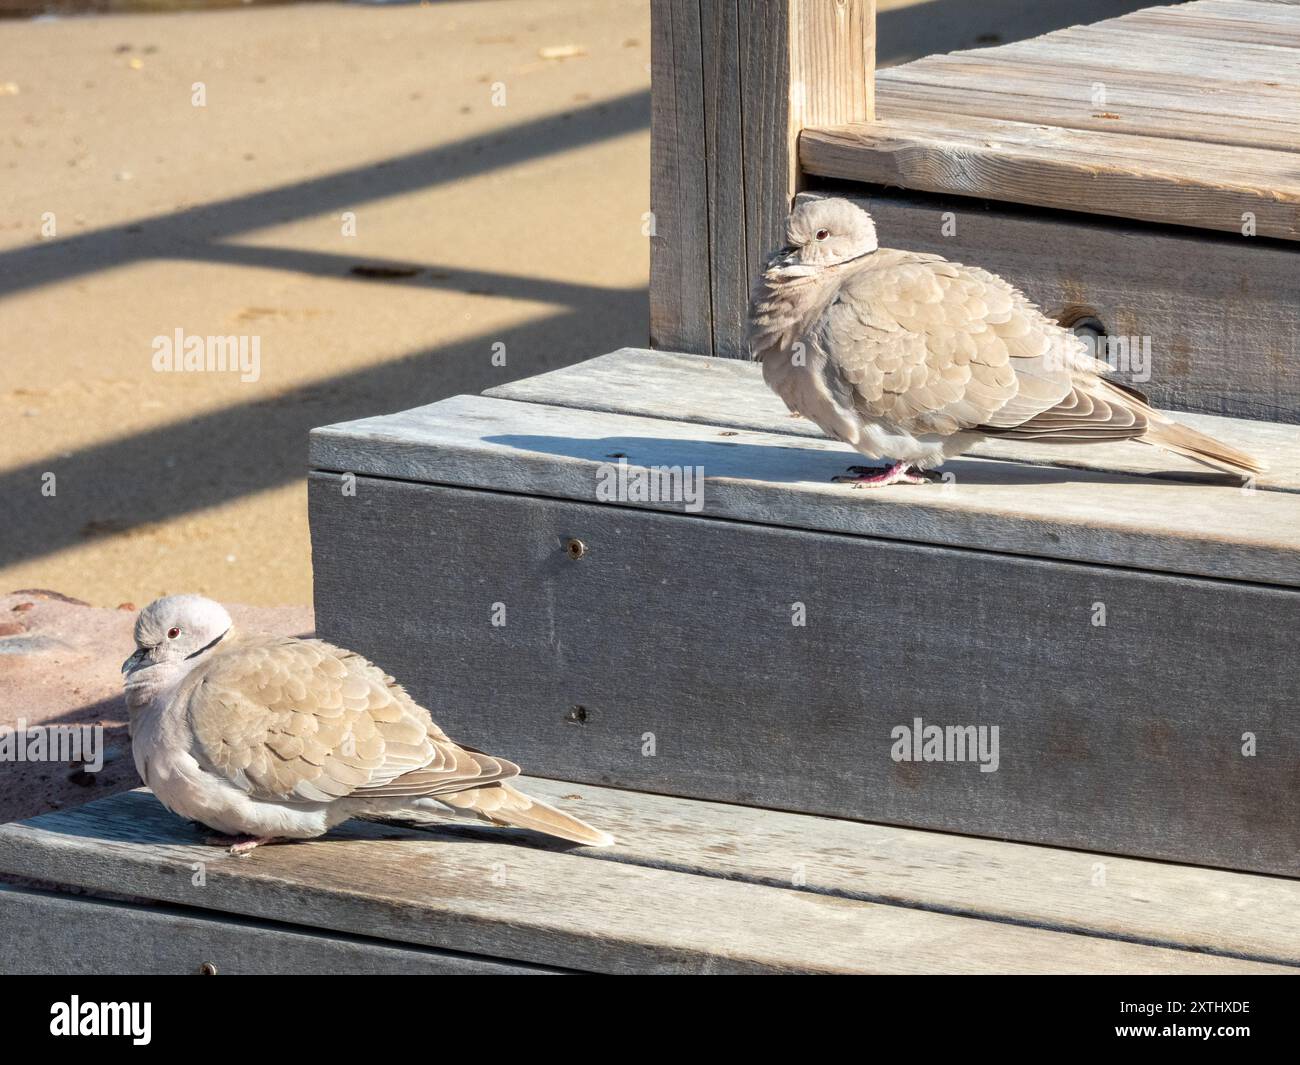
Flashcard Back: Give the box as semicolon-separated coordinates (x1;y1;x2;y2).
182;636;519;802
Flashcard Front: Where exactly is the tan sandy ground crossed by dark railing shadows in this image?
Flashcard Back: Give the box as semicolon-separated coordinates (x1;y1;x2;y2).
0;0;1139;606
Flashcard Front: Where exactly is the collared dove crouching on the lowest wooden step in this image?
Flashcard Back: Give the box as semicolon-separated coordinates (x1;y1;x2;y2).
122;596;614;853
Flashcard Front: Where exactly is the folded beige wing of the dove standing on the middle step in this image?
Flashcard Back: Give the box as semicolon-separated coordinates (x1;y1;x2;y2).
811;248;1145;440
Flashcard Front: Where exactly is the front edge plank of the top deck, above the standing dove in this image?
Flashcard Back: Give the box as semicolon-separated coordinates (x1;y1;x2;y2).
800;108;1300;241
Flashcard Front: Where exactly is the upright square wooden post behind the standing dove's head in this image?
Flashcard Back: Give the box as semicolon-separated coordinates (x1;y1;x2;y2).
650;0;876;358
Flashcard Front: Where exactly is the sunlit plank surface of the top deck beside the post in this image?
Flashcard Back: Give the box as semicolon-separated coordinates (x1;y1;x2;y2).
800;0;1300;241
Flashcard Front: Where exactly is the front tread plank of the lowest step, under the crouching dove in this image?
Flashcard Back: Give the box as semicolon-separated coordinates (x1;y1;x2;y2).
0;792;1294;973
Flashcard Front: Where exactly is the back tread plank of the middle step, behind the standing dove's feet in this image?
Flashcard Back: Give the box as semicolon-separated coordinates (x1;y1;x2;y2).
484;347;1300;492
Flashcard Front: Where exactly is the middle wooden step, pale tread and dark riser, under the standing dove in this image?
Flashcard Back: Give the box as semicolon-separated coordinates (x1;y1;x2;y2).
309;350;1300;875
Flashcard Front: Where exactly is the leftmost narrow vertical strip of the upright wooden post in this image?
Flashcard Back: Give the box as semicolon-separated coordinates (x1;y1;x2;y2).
650;0;712;354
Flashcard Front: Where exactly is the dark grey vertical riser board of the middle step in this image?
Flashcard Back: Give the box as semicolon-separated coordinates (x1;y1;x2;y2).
309;475;1300;875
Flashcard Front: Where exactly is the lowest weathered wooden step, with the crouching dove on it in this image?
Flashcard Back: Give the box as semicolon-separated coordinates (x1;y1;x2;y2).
0;779;1300;974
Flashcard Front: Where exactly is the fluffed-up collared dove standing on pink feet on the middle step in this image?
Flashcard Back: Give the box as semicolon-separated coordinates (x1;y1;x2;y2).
750;199;1264;486
